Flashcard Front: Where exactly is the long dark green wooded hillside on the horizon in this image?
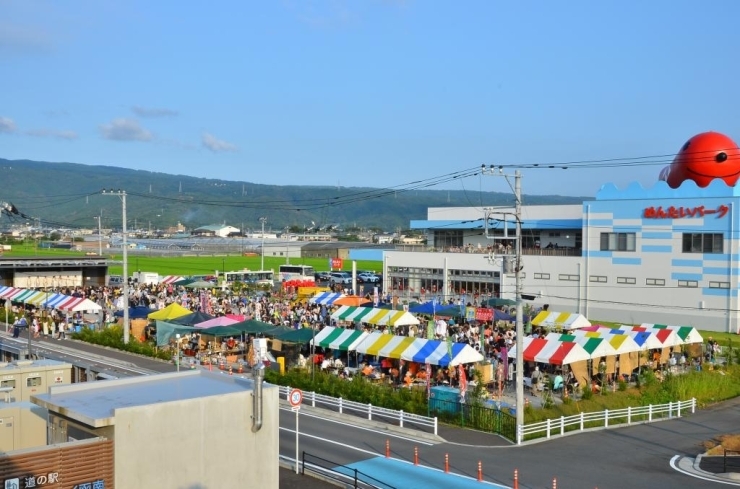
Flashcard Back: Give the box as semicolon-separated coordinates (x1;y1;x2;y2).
0;158;588;232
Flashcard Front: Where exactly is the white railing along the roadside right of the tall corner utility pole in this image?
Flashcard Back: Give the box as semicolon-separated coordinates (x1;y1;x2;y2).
517;399;696;444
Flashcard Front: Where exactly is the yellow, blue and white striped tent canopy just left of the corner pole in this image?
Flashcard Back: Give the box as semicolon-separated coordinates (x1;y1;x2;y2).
356;331;483;366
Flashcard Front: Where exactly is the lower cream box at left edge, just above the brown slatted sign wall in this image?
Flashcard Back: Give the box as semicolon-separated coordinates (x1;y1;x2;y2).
0;402;49;453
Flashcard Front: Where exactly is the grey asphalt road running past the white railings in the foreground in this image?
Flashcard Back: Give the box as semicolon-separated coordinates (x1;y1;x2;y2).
14;337;740;489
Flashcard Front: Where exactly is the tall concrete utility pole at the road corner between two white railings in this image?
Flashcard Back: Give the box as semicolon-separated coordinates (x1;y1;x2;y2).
481;165;524;444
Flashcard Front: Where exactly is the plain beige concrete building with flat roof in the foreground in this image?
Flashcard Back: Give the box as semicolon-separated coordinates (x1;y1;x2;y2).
32;370;279;489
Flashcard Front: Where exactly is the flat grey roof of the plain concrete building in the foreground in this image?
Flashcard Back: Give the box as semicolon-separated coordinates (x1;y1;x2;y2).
31;370;277;428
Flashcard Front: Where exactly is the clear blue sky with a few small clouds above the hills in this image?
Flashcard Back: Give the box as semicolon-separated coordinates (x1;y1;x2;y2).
0;0;740;196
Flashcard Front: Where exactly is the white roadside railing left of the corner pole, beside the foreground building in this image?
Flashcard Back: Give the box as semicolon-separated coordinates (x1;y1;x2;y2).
279;385;437;435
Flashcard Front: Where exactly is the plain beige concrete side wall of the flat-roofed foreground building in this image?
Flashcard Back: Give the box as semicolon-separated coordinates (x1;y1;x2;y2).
115;385;279;489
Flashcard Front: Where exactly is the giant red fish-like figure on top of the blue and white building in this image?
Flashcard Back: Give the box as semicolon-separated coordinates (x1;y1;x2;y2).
658;132;740;188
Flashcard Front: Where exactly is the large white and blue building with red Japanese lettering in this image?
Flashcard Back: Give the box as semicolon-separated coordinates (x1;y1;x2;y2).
384;180;740;333
